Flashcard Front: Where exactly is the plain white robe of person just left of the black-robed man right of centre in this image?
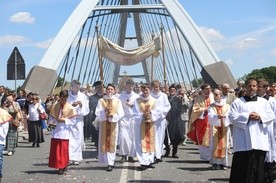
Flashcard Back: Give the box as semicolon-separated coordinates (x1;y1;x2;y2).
150;91;171;159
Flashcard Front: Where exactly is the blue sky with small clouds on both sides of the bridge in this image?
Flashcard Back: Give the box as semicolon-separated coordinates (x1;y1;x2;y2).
0;0;276;89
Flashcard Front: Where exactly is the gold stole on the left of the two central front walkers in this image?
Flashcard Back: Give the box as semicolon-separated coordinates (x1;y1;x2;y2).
100;98;118;153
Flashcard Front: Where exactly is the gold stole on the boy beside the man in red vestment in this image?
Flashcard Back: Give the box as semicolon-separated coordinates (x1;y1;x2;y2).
211;105;229;158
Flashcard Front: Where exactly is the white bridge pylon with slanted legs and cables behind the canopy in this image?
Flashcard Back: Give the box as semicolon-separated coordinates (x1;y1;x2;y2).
22;0;235;100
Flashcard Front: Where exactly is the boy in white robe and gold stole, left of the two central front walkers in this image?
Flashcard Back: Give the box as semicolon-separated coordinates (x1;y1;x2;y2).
95;84;124;171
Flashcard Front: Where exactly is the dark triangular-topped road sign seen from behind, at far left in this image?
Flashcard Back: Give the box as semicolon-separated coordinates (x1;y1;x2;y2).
7;47;25;80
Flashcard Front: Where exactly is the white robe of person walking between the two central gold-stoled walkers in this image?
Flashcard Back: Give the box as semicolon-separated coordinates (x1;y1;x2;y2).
118;91;140;157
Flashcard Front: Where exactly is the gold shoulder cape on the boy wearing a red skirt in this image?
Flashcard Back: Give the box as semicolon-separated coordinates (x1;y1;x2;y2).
50;102;77;119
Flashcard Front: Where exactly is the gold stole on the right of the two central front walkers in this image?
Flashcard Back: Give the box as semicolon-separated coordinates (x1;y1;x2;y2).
138;98;155;152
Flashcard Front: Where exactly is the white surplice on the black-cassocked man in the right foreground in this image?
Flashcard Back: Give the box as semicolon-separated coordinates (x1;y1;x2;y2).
229;97;275;152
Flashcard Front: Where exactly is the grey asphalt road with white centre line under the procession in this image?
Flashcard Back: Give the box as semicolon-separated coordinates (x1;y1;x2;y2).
2;131;232;183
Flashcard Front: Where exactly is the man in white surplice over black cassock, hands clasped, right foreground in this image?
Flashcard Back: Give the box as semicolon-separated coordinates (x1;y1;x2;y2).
229;78;275;183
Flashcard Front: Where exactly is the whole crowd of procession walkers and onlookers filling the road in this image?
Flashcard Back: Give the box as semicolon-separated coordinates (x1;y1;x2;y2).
0;78;276;183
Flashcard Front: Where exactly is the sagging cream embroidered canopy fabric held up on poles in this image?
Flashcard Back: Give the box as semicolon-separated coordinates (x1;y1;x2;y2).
99;36;161;65
